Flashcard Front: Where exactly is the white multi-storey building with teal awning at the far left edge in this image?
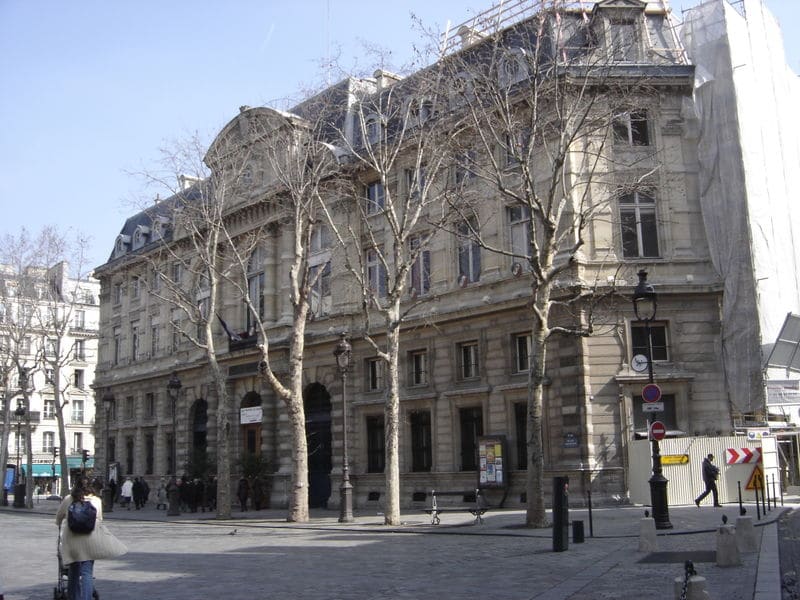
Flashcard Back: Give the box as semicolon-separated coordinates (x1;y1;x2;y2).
0;262;100;489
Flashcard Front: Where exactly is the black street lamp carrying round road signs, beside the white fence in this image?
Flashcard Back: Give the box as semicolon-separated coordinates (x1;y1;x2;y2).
633;269;672;529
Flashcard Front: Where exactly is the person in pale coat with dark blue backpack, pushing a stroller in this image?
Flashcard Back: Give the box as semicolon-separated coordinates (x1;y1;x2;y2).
56;477;128;600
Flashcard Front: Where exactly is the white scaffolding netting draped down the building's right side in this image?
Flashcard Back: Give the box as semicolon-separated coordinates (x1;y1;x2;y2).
681;0;800;413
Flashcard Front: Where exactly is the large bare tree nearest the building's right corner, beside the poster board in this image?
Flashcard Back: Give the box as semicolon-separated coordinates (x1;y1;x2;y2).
441;1;657;527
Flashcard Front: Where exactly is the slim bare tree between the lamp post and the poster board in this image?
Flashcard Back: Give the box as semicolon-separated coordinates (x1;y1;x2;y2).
324;68;460;525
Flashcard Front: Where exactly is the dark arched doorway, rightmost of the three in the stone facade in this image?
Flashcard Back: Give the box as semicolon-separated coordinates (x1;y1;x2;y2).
303;383;333;508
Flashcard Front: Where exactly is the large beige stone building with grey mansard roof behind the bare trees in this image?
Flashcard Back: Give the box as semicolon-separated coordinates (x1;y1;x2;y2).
96;0;733;507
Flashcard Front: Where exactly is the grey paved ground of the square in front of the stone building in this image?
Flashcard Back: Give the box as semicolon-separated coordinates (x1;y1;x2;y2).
0;501;781;600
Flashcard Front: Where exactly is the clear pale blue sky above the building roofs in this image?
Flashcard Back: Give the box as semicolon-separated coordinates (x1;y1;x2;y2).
0;0;800;266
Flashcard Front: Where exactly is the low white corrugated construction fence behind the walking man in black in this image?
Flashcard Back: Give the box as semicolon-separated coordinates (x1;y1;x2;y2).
628;435;781;506
